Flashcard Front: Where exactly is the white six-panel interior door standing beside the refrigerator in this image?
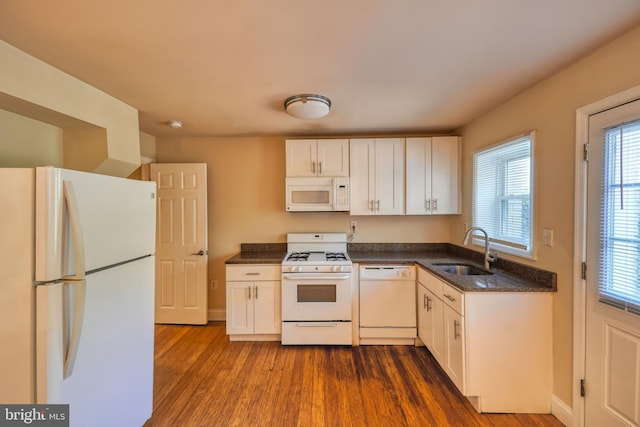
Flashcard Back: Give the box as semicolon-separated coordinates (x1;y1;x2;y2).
151;163;208;325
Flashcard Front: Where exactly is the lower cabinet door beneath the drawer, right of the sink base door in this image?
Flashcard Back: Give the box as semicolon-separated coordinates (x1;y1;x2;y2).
443;305;465;394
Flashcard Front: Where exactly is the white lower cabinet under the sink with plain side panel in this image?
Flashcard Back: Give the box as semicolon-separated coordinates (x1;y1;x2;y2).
418;268;552;413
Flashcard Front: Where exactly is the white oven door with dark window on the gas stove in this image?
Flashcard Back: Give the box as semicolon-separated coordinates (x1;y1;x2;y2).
282;273;352;322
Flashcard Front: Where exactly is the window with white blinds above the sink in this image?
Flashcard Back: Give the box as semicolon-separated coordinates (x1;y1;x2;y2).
473;132;534;258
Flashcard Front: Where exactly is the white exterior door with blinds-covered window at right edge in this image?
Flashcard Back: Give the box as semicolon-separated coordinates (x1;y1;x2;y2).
585;101;640;427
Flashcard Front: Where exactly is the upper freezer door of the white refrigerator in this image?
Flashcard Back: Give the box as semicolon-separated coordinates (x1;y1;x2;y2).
35;167;156;282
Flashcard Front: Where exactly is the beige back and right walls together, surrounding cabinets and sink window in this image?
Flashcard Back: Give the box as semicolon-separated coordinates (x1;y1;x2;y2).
156;22;640;412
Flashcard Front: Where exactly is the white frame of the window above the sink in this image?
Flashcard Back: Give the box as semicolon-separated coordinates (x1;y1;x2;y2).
471;131;536;259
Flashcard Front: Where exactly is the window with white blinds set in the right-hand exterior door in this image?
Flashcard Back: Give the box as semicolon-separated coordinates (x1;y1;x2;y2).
600;121;640;314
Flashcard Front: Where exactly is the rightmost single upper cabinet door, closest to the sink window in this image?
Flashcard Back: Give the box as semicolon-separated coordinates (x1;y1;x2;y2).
431;136;460;215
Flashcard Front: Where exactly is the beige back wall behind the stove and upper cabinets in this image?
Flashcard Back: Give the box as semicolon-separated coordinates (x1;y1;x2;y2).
156;137;449;316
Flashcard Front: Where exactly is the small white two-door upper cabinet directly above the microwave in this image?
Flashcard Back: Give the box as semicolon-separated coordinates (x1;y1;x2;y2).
285;139;349;177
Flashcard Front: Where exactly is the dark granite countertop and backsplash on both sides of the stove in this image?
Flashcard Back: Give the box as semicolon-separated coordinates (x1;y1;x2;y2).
226;243;557;292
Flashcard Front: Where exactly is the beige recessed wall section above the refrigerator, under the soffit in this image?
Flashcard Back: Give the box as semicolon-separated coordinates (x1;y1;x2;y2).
0;110;63;167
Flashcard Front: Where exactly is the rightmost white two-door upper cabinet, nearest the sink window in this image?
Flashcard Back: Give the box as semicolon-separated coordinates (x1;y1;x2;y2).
406;136;460;215
